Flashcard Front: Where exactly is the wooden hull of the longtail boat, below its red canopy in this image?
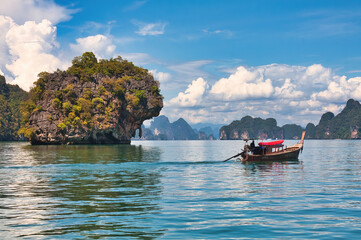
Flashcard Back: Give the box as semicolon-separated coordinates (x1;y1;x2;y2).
242;148;301;162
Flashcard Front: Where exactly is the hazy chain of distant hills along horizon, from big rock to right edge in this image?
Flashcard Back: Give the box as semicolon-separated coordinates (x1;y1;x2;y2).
136;99;361;140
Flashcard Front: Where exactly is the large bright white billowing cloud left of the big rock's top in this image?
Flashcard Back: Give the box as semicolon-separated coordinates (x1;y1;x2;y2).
5;20;63;90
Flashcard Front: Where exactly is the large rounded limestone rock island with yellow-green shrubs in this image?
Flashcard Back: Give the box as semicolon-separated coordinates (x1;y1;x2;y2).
19;52;163;144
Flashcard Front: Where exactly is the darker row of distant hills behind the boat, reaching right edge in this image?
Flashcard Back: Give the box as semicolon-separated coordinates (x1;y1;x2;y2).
219;99;361;140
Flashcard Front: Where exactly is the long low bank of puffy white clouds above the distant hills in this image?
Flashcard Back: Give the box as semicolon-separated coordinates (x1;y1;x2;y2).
164;64;361;125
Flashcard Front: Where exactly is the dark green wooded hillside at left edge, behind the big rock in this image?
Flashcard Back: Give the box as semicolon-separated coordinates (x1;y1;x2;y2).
0;75;28;141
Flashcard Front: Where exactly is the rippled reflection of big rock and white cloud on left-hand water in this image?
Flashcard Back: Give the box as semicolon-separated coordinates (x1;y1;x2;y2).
0;143;163;238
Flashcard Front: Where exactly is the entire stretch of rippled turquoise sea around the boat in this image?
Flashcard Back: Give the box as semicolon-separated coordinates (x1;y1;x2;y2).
0;140;361;239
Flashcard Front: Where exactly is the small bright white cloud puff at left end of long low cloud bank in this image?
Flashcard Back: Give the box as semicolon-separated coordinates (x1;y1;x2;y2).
169;78;208;107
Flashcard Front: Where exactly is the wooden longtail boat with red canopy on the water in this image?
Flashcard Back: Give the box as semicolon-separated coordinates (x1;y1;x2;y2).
224;132;306;162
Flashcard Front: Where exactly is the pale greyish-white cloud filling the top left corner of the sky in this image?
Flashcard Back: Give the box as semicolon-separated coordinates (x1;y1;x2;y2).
0;0;76;24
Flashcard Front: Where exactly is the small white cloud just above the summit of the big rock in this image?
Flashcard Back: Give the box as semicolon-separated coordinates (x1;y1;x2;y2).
70;34;116;59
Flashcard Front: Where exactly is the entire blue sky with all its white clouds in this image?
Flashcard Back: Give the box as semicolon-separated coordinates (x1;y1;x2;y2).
0;0;361;126
